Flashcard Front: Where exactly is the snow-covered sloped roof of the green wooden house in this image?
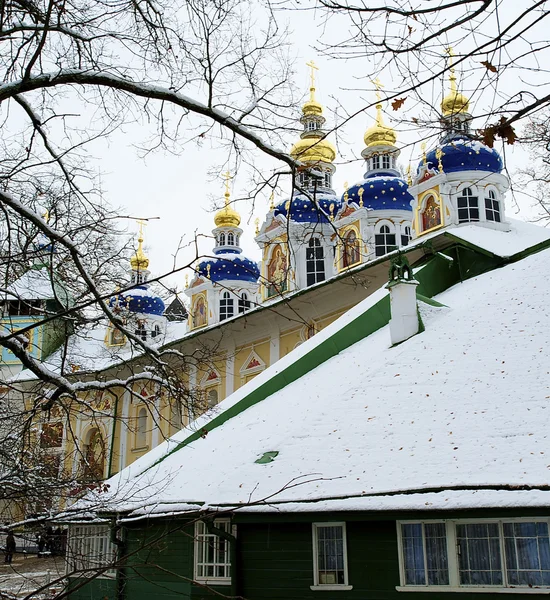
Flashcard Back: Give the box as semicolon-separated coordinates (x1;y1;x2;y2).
83;244;550;518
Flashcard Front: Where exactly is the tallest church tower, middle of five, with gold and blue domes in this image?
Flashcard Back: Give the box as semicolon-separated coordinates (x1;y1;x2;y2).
256;62;340;300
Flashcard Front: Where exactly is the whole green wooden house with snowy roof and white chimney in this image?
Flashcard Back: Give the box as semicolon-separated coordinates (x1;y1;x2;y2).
67;223;550;600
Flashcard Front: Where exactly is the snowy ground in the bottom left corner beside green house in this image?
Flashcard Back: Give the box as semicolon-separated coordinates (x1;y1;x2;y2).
0;554;65;599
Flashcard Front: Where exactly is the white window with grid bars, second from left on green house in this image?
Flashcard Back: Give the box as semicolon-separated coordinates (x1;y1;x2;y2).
193;519;236;585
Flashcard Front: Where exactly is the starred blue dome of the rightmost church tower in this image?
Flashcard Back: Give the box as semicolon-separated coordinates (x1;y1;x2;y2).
424;138;504;173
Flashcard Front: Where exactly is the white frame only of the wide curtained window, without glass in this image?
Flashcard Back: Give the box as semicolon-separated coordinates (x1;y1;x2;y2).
395;517;550;595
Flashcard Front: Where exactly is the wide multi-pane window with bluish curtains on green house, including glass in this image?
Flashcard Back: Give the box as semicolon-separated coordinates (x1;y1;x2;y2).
396;517;550;594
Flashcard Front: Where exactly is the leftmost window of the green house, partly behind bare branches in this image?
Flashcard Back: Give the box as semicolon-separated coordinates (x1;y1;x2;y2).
66;525;116;578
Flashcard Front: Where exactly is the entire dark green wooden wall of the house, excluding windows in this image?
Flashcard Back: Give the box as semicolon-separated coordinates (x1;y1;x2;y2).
70;510;550;600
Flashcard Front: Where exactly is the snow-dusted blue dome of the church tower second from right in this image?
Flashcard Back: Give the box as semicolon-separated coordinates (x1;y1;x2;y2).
342;176;413;211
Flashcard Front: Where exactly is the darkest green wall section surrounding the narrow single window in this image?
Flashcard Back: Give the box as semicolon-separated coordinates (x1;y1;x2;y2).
238;513;550;600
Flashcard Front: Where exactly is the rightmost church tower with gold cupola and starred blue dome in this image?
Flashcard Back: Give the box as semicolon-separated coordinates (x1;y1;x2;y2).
410;49;509;237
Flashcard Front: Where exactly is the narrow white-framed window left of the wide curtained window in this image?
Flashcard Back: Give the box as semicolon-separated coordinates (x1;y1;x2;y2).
310;522;353;591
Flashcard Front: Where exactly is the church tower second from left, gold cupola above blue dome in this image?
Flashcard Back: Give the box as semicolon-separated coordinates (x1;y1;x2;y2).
185;173;260;329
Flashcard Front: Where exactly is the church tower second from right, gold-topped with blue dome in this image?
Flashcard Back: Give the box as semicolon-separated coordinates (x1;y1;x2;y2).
334;80;413;271
